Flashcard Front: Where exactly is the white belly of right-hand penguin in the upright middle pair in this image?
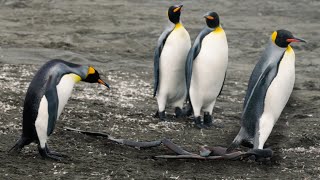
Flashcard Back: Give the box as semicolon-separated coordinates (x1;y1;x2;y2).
190;32;228;111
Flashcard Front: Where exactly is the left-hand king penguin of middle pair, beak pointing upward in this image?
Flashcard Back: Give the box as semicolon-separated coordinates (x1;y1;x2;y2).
153;5;191;120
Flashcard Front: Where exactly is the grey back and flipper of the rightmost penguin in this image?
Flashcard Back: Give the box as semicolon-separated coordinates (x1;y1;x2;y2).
241;40;286;137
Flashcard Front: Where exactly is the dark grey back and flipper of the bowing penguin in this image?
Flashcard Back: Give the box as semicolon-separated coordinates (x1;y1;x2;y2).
23;59;88;138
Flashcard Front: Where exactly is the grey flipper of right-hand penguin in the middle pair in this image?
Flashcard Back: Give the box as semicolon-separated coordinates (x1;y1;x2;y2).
185;27;213;94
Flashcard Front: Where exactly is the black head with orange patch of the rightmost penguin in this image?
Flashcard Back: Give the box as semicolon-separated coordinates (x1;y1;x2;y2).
271;29;306;48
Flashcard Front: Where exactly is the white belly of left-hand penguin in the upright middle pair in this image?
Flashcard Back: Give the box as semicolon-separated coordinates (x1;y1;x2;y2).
158;27;191;104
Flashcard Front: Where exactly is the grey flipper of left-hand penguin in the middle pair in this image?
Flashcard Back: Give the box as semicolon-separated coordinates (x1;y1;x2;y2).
153;26;174;97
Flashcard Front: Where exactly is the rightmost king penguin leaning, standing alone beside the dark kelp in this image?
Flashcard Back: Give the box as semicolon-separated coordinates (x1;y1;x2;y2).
228;30;305;152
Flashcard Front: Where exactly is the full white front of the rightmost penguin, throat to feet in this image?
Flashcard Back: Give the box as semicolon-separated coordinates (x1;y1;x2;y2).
254;48;295;149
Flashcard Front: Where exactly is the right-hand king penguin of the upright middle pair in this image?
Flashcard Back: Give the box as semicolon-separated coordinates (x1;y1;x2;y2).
186;12;228;128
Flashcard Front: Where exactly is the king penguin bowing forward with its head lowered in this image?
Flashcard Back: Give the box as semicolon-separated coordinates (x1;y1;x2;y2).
10;59;109;160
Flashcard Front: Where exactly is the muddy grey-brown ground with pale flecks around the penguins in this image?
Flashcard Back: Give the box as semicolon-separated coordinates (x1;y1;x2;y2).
0;0;320;179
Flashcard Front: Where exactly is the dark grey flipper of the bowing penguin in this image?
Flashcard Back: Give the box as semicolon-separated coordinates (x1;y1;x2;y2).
45;76;59;136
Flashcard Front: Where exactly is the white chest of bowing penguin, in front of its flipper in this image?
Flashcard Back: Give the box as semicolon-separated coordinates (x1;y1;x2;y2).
57;74;81;118
